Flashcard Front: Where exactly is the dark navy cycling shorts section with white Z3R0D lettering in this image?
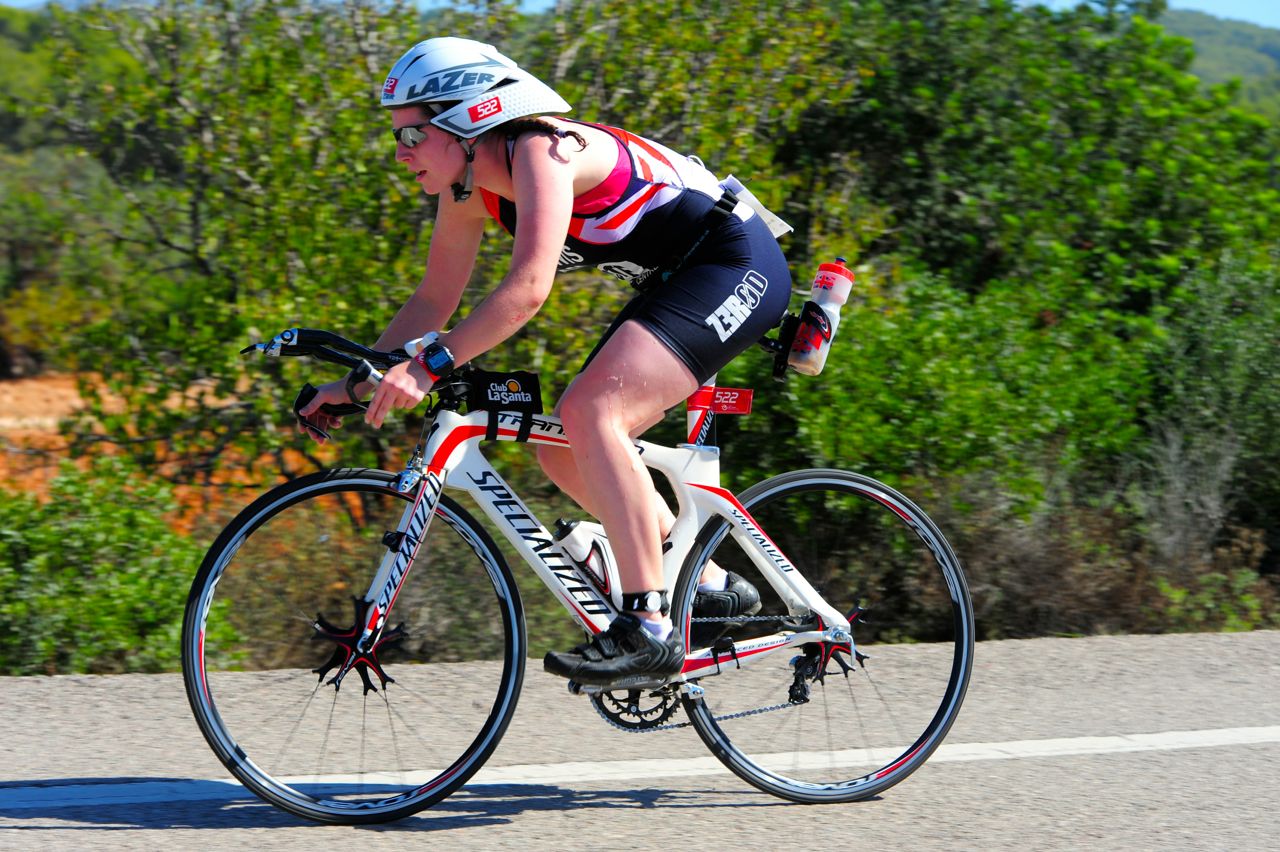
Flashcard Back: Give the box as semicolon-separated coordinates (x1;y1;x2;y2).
582;208;791;384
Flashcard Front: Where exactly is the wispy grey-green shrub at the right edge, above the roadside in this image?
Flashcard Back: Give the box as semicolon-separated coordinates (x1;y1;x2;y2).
1140;258;1280;580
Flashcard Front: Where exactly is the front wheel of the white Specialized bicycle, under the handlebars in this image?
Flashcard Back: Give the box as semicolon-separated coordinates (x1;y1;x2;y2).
182;469;526;824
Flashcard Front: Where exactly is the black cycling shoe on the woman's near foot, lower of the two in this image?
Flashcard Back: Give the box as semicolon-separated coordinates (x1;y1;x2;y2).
543;613;685;686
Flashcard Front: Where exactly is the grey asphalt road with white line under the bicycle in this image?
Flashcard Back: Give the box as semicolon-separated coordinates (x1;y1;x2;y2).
0;632;1280;851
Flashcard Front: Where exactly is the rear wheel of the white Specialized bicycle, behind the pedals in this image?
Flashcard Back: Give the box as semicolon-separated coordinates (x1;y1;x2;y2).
676;469;973;802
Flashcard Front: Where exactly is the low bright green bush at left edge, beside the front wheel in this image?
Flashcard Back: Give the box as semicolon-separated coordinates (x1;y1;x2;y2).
0;458;201;674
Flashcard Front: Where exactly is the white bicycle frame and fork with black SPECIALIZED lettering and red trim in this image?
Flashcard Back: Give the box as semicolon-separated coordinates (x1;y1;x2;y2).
361;401;854;681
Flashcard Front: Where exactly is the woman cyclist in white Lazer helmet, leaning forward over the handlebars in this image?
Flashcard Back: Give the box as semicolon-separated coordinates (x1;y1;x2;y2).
301;37;791;684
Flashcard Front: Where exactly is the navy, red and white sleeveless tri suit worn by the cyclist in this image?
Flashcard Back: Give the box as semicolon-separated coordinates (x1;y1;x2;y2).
480;122;791;383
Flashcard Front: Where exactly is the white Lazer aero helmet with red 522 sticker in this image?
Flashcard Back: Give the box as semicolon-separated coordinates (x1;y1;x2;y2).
381;37;573;139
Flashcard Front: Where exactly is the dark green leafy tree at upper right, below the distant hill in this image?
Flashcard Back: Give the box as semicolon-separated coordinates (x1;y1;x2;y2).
803;0;1280;295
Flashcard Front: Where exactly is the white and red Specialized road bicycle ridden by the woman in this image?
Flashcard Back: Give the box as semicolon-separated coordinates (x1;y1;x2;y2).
182;323;974;824
